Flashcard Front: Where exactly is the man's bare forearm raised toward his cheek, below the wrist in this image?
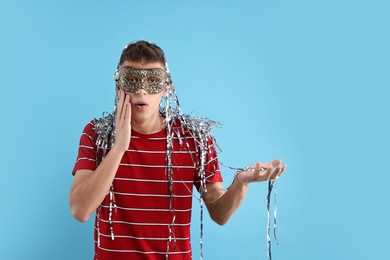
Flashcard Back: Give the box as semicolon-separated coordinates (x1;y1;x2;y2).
69;149;123;222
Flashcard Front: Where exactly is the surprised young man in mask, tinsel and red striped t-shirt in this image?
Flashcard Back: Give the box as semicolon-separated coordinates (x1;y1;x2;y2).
69;41;286;260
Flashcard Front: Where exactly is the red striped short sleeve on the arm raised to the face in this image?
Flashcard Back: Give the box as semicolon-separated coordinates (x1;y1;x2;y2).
72;121;97;175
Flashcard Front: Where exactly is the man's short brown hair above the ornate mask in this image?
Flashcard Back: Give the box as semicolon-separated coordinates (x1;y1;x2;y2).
118;41;166;67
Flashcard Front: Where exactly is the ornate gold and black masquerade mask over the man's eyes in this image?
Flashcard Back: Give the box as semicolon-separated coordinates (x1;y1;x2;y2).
114;66;170;94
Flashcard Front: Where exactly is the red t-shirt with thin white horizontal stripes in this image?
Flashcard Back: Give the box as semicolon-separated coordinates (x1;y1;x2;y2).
73;121;222;260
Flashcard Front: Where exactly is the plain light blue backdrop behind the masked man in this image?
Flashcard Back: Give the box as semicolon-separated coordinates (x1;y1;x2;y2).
0;0;390;260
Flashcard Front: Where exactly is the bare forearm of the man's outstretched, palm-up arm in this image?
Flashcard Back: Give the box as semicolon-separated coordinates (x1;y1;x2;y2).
206;179;248;225
